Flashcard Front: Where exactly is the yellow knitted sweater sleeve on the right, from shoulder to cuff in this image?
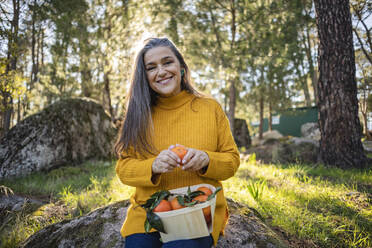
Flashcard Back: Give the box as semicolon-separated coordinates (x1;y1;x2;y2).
199;101;240;181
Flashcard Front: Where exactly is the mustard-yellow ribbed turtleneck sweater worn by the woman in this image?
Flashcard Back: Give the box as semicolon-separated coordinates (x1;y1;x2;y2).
116;91;240;245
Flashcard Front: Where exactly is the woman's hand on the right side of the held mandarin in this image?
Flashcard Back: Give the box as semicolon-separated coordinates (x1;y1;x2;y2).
182;148;209;171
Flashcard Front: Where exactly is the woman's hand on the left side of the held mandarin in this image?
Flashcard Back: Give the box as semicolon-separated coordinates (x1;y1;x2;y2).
152;146;181;174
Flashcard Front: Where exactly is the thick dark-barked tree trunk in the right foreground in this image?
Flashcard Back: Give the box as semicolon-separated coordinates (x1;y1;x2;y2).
315;0;367;168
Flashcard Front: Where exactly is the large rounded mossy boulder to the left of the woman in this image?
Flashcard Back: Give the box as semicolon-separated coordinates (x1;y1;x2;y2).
0;99;116;179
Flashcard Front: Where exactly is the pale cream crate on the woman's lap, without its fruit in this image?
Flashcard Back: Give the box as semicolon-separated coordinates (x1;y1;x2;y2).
156;184;217;242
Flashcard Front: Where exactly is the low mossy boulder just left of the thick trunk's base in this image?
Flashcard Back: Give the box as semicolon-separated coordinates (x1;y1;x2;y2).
272;138;319;164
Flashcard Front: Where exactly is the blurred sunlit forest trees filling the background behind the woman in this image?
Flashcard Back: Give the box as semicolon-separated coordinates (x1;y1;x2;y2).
0;0;372;138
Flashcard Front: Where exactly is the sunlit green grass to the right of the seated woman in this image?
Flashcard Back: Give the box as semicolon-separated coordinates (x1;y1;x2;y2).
223;157;372;247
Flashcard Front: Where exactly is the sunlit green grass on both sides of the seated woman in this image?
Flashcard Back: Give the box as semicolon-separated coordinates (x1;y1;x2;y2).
0;156;372;247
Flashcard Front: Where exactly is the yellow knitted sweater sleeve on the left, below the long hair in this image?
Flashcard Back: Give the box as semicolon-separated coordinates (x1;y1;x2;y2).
115;149;160;187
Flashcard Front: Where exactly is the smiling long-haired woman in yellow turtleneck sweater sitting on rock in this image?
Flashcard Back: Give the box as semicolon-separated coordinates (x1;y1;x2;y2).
115;38;240;248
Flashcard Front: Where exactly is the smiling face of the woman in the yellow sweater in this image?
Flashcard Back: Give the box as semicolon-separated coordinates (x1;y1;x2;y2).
144;47;181;97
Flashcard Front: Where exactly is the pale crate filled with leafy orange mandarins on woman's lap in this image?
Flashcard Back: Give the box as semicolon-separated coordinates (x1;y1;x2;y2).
141;184;221;242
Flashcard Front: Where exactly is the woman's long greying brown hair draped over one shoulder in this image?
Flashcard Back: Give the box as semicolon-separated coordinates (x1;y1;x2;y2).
115;38;201;157
